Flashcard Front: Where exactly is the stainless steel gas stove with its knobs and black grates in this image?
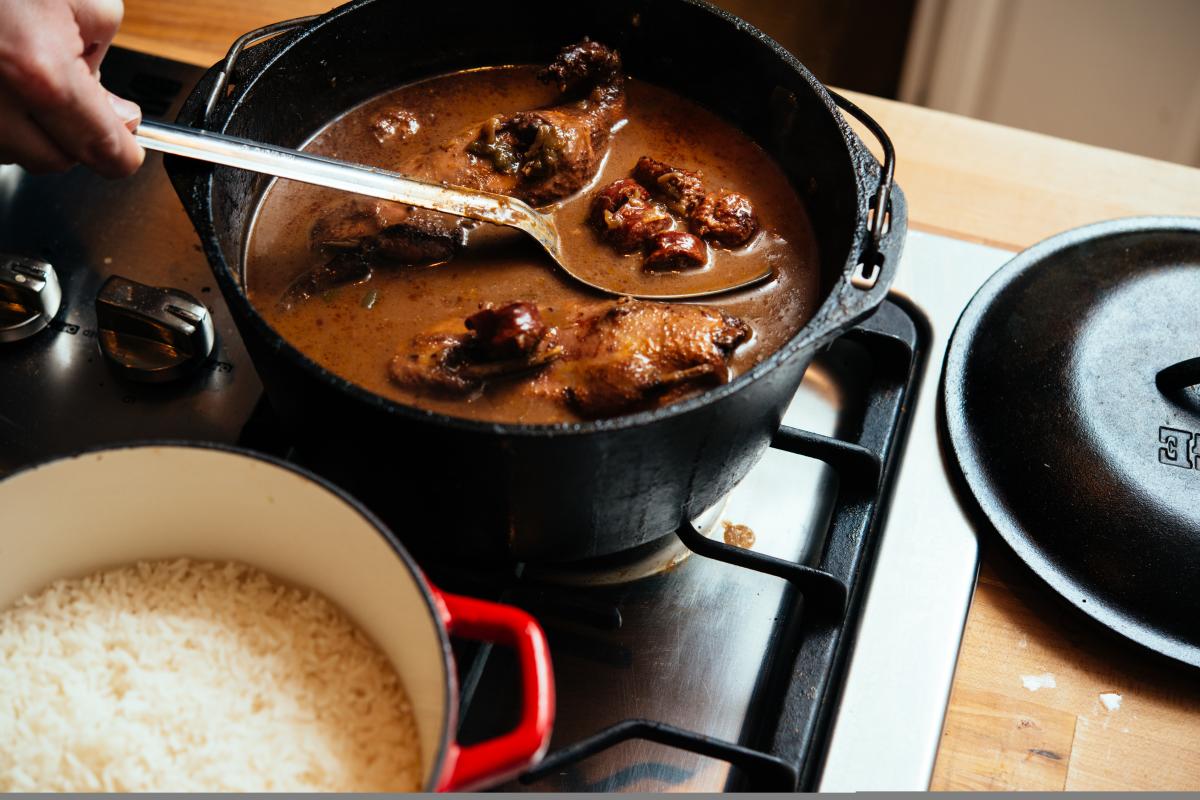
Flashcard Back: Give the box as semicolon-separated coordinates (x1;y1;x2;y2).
0;49;1008;792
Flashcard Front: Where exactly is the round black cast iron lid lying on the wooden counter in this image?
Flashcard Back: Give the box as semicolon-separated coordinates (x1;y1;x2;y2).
942;217;1200;666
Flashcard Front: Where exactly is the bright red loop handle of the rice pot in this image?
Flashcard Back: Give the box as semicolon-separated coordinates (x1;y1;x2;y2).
433;589;554;792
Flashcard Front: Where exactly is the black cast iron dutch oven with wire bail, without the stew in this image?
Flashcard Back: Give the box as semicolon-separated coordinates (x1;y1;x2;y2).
166;0;906;561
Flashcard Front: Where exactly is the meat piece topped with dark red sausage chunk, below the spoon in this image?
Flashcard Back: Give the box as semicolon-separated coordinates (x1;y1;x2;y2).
389;302;563;395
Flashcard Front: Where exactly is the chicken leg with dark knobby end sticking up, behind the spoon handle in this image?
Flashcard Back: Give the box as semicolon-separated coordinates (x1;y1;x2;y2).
412;41;625;205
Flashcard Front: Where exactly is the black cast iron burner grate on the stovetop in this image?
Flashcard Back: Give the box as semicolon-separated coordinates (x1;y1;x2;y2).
422;301;928;792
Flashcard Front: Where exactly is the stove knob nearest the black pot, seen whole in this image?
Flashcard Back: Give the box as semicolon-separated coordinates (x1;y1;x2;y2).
96;275;216;383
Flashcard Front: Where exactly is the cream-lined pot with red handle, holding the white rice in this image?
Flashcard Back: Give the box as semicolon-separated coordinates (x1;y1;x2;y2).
0;444;554;792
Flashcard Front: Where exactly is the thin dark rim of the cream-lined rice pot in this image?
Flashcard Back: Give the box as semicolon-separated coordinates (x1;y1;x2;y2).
0;439;458;792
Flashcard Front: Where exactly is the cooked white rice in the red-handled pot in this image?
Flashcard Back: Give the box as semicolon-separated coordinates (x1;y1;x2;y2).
0;559;421;792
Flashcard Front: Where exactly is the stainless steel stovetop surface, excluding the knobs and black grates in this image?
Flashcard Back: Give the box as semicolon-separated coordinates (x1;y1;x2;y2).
0;50;1008;790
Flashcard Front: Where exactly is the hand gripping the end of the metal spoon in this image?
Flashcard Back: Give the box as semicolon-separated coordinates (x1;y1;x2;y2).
0;0;145;178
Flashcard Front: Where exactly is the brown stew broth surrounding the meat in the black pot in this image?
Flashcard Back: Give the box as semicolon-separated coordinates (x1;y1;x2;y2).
245;67;820;423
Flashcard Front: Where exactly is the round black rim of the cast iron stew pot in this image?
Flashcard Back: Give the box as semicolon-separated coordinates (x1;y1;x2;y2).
193;0;907;439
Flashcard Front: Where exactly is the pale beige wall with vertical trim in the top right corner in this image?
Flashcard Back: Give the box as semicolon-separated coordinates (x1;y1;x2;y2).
900;0;1200;166
